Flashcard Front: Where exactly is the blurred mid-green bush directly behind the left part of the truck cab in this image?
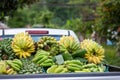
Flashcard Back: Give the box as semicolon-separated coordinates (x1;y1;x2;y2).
7;4;53;27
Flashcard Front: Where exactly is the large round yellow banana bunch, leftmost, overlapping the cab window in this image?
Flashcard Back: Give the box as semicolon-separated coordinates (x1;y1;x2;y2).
12;32;35;58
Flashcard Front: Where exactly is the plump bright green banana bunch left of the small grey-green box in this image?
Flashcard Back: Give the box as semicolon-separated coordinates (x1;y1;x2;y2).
32;50;54;67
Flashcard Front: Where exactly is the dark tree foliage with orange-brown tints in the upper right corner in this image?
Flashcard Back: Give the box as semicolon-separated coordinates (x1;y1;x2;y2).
95;0;120;41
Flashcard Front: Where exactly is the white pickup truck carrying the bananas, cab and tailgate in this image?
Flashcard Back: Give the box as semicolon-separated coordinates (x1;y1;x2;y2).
0;28;120;80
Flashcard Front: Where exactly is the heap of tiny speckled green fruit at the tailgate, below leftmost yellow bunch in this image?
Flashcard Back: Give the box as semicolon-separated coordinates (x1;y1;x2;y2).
18;56;43;74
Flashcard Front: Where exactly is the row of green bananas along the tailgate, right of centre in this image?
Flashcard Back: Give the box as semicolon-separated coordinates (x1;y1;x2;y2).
47;60;106;73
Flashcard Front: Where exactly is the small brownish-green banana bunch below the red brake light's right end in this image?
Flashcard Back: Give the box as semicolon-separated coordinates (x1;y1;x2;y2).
37;36;59;56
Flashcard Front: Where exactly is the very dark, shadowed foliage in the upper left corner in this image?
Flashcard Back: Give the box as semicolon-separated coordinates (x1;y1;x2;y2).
0;0;39;20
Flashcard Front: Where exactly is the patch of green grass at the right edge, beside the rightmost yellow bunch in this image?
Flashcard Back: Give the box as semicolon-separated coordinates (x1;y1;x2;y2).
103;45;120;66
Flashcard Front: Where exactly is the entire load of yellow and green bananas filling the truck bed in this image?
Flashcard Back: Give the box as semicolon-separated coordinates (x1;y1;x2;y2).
0;32;106;75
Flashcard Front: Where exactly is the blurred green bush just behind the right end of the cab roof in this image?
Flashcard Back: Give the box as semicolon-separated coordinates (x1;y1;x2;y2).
63;18;93;38
